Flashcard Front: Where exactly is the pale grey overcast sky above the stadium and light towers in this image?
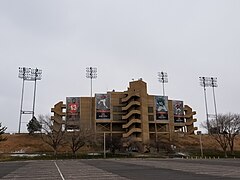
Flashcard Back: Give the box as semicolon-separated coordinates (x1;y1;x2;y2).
0;0;240;132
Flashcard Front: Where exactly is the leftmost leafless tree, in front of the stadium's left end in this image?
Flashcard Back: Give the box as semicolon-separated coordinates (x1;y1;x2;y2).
39;115;65;156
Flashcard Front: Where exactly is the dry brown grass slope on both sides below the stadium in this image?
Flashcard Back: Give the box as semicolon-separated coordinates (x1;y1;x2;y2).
0;134;240;153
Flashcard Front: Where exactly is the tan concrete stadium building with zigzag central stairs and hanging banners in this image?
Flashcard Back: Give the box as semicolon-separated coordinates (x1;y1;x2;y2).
51;79;197;143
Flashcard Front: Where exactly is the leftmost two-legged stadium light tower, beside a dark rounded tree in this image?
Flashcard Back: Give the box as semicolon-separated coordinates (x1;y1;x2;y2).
18;67;42;133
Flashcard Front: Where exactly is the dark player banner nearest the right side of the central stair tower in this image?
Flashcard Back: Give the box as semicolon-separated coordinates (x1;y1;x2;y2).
155;96;168;120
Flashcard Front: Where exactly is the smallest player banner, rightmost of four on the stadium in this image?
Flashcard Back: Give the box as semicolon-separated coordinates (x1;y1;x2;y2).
173;101;184;123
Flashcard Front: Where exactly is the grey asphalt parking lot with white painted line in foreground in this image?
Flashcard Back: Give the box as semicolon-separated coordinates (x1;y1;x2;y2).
0;159;240;180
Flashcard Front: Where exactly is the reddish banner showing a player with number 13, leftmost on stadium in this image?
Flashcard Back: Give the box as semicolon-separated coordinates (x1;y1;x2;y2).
66;97;80;121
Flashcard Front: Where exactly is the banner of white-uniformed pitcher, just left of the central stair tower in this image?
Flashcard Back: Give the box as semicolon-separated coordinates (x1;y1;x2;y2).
95;94;110;119
